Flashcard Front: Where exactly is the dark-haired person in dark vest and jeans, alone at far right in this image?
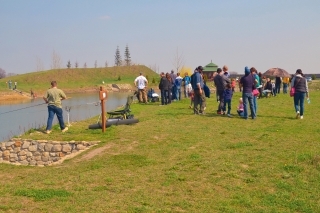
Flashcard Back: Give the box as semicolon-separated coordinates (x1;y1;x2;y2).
291;69;309;119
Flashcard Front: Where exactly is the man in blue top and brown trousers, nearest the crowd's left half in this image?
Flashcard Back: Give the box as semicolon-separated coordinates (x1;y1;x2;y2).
191;66;206;115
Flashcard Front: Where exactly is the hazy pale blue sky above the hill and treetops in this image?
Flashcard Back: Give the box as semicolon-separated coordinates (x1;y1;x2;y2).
0;0;320;73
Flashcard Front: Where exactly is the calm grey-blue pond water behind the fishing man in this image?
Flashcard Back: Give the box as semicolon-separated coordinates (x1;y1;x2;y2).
0;92;131;142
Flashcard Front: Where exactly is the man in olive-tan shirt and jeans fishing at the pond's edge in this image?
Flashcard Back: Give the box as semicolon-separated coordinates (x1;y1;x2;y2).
43;81;68;134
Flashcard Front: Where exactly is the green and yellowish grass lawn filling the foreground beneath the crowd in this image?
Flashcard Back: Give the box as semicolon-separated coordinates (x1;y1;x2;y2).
0;83;320;213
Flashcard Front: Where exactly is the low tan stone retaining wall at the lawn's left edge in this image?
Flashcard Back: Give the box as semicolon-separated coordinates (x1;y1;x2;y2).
0;138;99;166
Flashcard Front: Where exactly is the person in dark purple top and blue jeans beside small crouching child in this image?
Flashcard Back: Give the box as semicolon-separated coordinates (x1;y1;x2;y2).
240;67;256;119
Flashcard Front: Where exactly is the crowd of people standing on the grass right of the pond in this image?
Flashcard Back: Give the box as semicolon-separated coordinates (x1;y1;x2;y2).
134;65;309;119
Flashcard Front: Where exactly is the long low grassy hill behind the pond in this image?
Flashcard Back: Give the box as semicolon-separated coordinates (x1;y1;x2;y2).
0;65;159;92
